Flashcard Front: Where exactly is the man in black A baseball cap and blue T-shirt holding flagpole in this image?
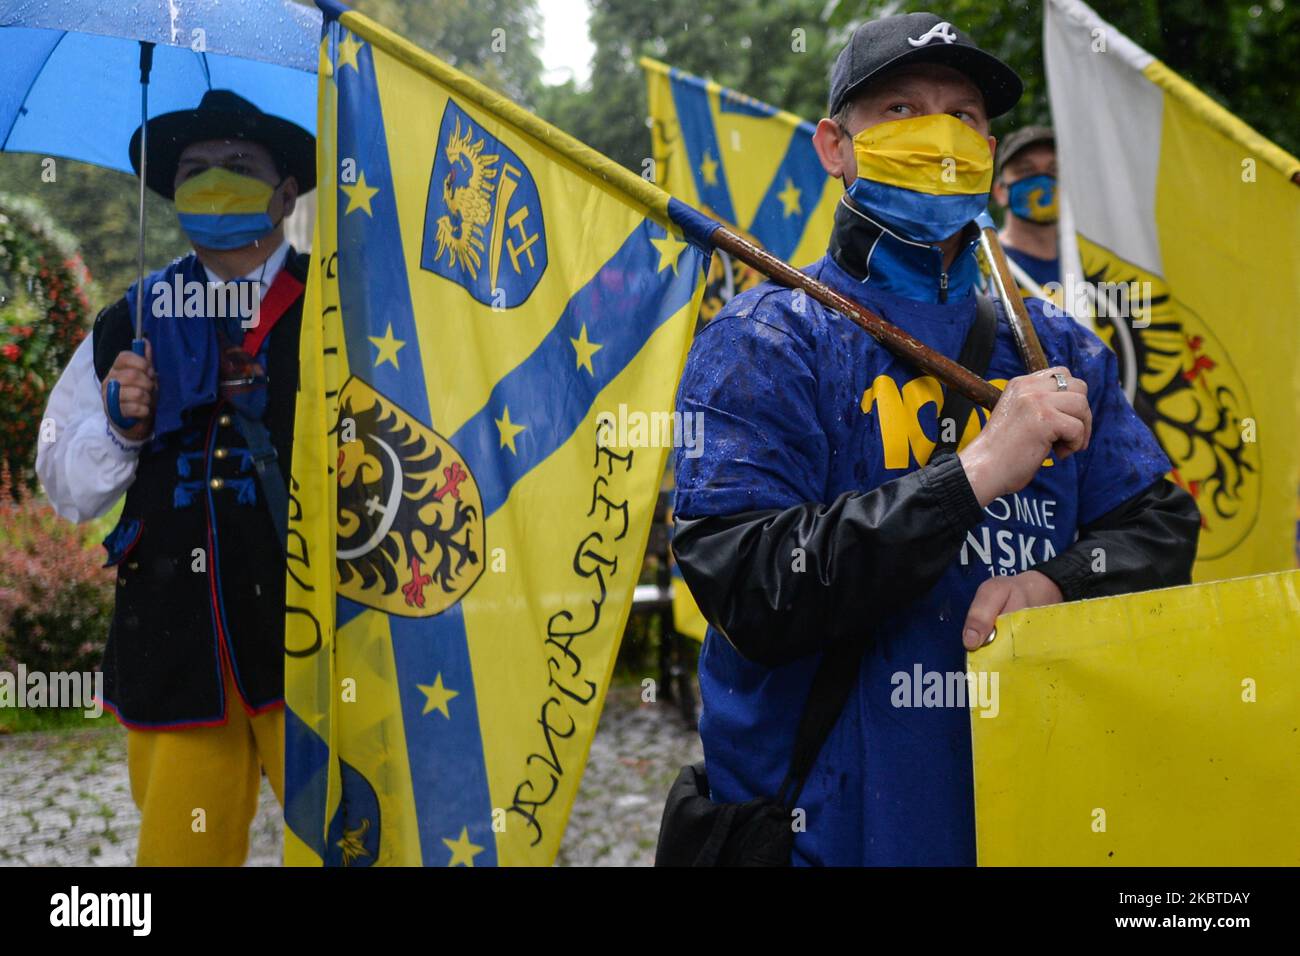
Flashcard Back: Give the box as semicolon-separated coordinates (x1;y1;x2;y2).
673;13;1200;865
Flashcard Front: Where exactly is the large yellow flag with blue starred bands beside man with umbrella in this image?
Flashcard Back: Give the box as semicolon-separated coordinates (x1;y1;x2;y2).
285;0;712;866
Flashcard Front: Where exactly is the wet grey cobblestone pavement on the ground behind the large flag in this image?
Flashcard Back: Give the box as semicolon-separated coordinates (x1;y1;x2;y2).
0;687;701;866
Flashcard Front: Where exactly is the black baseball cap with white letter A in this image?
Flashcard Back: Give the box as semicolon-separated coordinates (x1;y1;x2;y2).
827;13;1024;118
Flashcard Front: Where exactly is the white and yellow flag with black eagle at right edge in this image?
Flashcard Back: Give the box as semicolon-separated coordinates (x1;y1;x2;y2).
1044;0;1300;580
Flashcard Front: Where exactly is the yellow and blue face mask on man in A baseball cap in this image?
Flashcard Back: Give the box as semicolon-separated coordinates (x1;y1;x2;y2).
848;113;993;242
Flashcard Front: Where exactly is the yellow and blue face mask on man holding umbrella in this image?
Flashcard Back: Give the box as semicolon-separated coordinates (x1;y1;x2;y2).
176;166;283;248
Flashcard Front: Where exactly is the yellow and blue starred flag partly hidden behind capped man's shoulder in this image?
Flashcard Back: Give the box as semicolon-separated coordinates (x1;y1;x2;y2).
641;57;842;319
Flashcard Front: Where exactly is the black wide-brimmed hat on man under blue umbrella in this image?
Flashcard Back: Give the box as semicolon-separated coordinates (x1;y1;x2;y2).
130;90;316;199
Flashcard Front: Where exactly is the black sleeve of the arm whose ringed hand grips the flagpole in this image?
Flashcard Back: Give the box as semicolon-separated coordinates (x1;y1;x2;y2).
672;454;984;667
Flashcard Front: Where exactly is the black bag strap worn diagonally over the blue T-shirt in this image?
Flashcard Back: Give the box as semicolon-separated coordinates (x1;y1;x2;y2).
776;295;997;810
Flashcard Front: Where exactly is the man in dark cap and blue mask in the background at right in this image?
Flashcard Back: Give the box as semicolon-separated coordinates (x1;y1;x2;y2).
993;126;1062;302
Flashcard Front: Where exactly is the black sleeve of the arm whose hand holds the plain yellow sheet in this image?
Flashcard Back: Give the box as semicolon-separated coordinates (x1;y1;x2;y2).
1034;477;1201;601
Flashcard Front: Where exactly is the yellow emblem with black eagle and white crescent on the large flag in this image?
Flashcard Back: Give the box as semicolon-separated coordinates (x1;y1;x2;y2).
335;377;484;618
